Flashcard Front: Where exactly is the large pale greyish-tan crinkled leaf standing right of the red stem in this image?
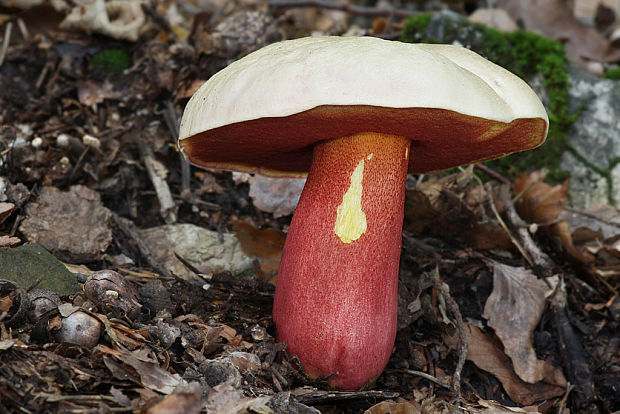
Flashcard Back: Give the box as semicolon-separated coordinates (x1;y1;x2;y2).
482;263;561;384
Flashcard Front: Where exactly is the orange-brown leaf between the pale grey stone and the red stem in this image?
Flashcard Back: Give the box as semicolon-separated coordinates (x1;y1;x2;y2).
233;221;286;284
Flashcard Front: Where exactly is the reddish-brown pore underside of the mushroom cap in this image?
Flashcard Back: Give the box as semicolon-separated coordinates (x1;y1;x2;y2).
179;105;547;177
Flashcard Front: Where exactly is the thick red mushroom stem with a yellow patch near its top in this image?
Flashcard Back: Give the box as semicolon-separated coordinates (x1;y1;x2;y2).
273;133;409;389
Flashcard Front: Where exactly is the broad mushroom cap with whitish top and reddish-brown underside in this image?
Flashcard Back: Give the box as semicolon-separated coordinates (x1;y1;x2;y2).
179;37;549;176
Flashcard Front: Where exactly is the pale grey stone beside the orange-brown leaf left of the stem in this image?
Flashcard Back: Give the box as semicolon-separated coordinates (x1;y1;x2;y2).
140;224;253;279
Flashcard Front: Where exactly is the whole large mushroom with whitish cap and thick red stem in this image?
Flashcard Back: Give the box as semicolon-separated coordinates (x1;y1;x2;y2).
179;37;549;389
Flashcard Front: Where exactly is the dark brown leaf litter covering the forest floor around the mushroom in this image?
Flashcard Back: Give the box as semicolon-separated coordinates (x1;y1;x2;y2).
0;1;620;414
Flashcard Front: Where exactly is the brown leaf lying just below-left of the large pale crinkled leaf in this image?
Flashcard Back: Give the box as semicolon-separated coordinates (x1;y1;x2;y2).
465;324;565;405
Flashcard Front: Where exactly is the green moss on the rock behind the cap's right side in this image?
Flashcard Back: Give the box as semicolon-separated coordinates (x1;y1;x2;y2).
401;14;578;180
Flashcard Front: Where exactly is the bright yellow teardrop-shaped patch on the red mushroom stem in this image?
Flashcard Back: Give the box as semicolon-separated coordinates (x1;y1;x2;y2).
334;156;372;243
